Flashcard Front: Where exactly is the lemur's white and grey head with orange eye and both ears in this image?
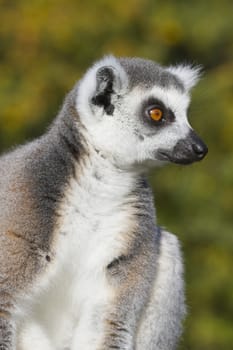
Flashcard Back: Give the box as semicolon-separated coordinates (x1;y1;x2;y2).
76;56;207;166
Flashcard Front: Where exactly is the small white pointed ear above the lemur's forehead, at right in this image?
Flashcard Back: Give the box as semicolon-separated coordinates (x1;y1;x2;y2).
168;65;202;91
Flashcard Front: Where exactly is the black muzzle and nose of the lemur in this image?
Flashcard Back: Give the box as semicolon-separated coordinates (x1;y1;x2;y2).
157;130;208;164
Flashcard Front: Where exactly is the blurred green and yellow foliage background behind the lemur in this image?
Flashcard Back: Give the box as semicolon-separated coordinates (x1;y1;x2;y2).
0;0;233;350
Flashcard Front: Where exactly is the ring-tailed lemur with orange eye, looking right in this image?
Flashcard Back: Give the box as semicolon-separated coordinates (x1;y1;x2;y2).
0;56;207;350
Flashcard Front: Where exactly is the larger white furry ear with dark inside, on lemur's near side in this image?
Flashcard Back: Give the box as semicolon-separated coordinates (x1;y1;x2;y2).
76;56;128;118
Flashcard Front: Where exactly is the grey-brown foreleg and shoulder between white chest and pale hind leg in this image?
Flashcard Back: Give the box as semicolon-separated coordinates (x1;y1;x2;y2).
101;177;161;350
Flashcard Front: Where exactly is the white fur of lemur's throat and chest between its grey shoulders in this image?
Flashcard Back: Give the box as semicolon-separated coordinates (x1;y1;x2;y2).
19;155;138;350
